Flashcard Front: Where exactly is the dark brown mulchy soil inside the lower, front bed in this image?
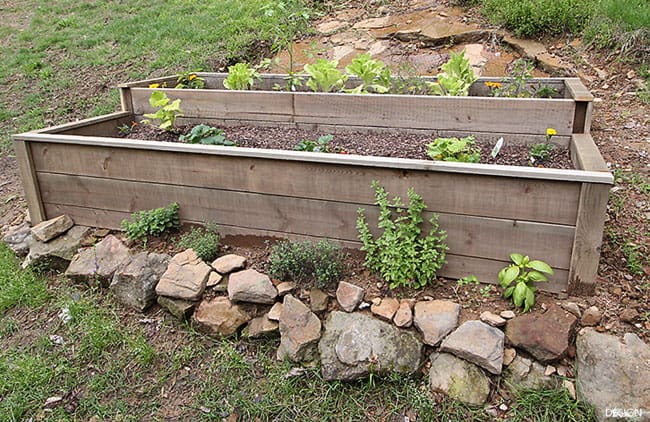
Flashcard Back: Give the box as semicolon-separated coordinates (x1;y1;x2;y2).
127;124;574;169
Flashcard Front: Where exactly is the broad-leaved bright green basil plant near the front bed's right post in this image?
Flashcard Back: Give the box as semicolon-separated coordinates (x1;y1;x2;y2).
498;253;553;312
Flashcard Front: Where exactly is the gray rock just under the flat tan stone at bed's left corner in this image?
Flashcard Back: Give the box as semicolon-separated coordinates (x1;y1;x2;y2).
22;226;90;272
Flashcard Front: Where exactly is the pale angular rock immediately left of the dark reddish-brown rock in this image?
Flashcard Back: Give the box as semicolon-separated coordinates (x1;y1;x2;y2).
440;321;505;375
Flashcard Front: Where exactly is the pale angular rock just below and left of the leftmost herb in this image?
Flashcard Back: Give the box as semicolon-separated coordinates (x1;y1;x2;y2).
65;235;132;287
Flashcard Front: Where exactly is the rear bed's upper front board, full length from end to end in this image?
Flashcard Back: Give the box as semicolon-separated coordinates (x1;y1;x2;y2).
131;88;575;135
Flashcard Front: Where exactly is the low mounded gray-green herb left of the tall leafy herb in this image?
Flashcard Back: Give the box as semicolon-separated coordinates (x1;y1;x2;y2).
269;240;346;288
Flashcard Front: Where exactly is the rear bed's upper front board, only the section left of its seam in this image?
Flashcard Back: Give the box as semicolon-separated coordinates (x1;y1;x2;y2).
131;88;293;122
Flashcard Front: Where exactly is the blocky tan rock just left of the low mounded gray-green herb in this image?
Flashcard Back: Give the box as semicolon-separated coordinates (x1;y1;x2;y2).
228;269;278;305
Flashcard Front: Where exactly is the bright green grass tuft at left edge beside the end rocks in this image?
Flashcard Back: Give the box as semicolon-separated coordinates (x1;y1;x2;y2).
0;242;49;315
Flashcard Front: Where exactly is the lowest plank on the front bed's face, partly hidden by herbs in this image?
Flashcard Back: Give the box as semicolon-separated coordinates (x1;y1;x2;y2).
45;203;568;292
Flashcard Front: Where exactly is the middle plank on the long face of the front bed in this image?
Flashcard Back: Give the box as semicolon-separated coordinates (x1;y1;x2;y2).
38;173;574;268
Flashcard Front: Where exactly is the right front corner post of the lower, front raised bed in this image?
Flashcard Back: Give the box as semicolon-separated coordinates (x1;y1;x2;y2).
569;183;610;294
